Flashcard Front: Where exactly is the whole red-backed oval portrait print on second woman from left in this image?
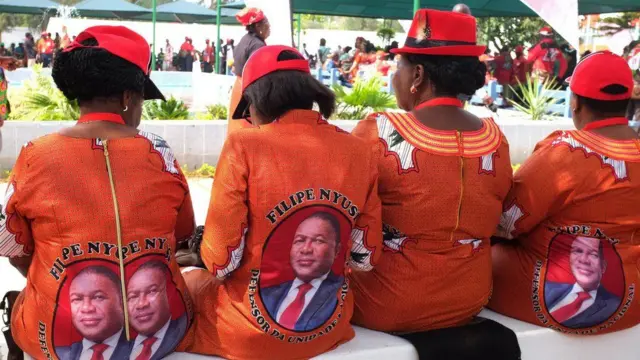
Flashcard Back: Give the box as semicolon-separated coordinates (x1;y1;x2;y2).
260;206;351;332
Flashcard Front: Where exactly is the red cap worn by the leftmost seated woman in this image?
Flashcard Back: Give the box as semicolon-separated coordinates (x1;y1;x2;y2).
63;26;165;100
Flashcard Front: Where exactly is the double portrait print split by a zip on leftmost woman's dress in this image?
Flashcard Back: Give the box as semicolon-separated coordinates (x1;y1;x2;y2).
53;255;189;360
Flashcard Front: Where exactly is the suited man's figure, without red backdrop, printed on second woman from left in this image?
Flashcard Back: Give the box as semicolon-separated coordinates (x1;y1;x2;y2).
260;212;344;331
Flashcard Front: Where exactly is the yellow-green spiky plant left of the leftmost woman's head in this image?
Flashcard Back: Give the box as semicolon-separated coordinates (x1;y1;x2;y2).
10;65;80;121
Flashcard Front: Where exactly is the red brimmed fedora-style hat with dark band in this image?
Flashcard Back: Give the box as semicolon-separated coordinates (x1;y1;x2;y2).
391;9;486;56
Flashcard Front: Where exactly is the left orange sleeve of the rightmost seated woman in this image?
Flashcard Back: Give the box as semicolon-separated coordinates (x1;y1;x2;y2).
496;132;583;239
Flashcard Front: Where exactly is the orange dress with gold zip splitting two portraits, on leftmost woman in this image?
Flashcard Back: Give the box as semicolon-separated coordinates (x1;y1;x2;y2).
0;132;195;359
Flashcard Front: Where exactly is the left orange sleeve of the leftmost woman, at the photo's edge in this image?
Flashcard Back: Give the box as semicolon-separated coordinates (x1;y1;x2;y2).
0;144;34;258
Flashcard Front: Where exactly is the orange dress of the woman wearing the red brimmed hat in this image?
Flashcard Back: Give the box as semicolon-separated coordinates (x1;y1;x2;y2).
351;113;512;332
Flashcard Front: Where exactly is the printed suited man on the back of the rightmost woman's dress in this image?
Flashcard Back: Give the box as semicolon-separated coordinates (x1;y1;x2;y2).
544;237;621;329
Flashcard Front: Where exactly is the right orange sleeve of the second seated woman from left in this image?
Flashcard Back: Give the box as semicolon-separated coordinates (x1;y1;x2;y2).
349;145;382;271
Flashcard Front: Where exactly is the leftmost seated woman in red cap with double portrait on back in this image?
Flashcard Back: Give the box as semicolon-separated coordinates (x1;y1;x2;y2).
0;26;195;360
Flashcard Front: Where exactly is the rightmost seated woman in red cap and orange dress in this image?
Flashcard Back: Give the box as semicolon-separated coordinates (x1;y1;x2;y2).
489;52;640;334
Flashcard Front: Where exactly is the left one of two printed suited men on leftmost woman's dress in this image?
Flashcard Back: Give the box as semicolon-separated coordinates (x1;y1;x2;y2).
55;266;131;360
